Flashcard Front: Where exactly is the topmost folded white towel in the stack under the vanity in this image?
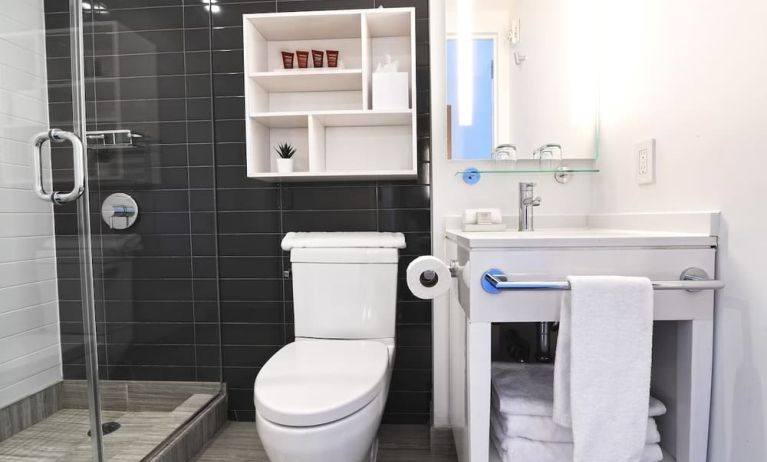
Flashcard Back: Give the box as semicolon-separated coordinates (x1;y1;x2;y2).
491;362;666;417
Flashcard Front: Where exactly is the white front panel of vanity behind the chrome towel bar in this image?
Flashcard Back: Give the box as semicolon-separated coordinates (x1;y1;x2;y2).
458;247;716;322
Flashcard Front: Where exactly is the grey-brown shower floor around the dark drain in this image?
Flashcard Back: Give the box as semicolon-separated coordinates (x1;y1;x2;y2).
0;394;213;462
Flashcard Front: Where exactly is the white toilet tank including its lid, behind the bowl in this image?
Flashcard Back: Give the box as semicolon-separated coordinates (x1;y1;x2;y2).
282;233;405;339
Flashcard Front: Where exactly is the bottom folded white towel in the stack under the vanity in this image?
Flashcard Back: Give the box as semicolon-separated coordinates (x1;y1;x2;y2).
490;431;663;462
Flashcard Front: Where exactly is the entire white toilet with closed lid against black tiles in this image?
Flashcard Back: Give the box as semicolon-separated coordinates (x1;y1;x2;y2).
254;233;405;462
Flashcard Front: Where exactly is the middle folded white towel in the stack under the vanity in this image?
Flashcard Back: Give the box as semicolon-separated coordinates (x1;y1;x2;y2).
490;409;660;444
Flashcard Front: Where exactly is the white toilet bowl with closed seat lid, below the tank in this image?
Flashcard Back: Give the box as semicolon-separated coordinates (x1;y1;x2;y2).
254;339;394;462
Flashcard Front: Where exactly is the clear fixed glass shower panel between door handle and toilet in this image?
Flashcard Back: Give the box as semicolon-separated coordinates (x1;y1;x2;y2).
73;0;221;456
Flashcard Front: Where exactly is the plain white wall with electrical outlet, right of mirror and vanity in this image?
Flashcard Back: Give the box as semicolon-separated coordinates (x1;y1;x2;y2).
592;0;767;462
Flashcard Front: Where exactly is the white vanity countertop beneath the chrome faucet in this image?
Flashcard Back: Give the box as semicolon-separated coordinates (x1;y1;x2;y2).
445;228;717;249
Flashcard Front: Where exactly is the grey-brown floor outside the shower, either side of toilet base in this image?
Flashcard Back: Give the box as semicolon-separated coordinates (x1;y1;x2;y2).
195;422;458;462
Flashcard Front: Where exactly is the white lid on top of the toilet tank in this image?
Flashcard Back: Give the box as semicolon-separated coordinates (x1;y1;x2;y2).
282;232;405;250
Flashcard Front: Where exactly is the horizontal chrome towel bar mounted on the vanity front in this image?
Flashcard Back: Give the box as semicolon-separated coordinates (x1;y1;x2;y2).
482;268;724;294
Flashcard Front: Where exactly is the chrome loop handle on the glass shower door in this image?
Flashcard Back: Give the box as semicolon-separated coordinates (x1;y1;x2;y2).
33;128;85;205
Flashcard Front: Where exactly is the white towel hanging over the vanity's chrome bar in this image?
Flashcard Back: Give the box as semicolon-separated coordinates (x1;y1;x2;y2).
553;276;653;462
